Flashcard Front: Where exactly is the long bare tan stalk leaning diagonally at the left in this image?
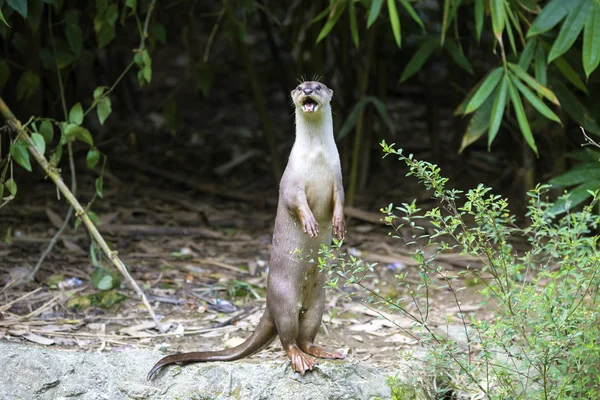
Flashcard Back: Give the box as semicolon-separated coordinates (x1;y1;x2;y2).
0;97;164;333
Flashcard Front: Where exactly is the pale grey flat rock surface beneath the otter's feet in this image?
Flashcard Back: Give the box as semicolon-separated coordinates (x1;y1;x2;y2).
0;341;406;400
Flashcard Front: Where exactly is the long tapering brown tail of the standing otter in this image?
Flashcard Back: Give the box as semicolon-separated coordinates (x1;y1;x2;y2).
148;309;277;380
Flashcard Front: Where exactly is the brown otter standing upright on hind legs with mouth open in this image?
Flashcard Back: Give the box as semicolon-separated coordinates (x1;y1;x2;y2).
148;82;344;379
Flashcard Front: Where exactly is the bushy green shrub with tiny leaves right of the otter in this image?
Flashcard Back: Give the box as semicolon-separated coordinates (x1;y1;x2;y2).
319;142;600;400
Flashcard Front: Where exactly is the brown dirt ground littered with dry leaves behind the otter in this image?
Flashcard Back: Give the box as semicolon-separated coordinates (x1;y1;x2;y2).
0;159;490;372
